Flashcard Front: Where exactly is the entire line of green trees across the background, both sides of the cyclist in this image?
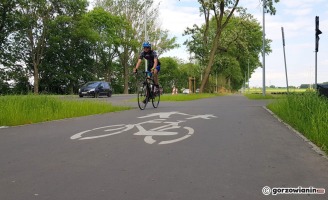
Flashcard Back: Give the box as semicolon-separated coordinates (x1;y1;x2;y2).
0;0;278;94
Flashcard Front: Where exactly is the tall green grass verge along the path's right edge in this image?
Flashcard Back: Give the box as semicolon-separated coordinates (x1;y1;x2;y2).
268;92;328;153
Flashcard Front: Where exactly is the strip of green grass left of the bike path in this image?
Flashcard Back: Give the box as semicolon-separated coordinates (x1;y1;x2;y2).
0;95;129;126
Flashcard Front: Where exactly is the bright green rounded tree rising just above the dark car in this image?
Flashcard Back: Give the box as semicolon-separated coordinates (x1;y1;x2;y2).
79;7;137;82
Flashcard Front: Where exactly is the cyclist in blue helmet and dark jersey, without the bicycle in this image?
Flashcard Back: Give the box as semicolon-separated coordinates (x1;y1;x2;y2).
133;42;161;90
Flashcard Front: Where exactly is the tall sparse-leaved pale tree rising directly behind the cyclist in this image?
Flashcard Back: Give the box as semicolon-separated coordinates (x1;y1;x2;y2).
96;0;177;93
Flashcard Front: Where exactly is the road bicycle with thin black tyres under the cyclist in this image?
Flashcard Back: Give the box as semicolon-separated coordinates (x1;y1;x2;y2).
136;71;161;110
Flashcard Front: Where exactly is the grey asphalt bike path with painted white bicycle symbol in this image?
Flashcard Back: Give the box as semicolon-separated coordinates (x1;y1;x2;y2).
0;95;328;200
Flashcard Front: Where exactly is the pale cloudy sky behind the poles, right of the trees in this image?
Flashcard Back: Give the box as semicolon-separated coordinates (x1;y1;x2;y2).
240;0;328;86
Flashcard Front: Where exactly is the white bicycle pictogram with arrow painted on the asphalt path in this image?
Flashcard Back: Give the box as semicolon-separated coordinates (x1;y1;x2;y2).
71;112;216;145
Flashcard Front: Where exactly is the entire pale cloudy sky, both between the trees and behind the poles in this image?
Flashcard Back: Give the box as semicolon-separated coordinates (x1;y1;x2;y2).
155;0;328;87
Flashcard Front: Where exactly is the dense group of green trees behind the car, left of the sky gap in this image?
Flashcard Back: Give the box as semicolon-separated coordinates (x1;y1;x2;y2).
0;0;177;94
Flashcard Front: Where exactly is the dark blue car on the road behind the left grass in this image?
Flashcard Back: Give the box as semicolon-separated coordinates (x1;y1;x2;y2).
79;81;113;98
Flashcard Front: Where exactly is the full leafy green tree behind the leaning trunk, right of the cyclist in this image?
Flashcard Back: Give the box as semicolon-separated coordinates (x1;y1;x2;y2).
185;8;271;90
